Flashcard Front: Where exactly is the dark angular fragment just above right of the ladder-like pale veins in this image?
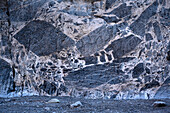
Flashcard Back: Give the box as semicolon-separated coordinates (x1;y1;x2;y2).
105;35;142;58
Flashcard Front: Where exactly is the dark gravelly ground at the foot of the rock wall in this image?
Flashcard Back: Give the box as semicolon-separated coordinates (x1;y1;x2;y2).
0;96;170;113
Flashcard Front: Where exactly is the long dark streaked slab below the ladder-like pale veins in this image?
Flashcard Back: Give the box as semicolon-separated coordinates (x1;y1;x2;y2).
64;58;130;88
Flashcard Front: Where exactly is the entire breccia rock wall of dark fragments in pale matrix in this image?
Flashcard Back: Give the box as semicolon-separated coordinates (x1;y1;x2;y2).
0;0;170;99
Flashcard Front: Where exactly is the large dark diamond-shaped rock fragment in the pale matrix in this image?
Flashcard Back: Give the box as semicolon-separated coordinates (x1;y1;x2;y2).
14;20;74;56
